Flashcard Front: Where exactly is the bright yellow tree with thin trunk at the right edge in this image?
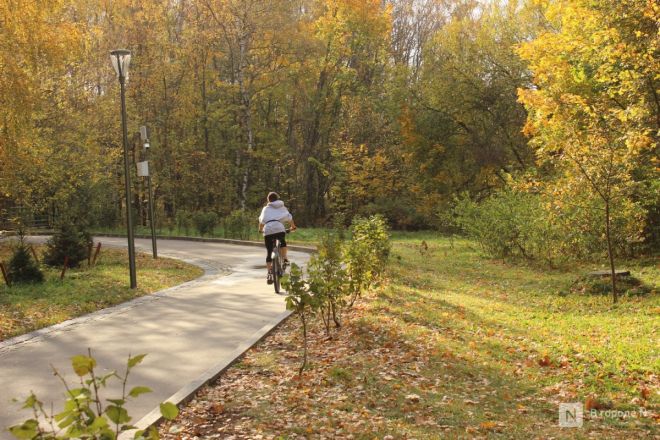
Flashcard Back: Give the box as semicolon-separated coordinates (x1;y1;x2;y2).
520;0;660;302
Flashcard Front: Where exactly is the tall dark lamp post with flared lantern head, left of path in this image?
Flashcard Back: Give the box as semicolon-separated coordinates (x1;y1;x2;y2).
110;49;137;289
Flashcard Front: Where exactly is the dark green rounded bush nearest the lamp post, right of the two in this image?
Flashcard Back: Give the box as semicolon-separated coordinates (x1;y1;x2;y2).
44;223;93;267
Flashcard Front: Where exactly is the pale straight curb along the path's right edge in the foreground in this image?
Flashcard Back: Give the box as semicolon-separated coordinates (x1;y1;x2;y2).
118;310;293;440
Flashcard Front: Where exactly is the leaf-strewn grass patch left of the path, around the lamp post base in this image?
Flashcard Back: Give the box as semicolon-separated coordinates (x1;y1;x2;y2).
0;243;203;340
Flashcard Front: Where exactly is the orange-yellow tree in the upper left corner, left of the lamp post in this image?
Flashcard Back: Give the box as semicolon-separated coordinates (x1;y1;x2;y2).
0;0;112;225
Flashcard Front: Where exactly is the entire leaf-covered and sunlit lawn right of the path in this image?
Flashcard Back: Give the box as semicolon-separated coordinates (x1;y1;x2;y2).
161;234;660;439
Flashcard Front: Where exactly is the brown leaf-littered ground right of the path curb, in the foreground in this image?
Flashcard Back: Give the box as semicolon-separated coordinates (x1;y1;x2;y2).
160;300;656;439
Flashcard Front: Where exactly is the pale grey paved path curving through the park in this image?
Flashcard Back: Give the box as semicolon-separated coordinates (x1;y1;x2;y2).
0;238;308;439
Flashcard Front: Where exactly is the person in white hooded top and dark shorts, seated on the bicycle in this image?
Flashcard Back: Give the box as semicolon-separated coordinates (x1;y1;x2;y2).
259;192;296;284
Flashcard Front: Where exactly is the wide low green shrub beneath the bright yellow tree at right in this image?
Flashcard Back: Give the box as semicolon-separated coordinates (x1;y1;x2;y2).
452;189;643;265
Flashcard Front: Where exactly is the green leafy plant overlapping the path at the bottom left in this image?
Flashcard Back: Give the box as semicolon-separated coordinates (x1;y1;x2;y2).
9;351;178;440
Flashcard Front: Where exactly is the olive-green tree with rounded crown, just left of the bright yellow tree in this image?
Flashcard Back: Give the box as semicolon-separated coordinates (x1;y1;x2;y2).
400;1;536;218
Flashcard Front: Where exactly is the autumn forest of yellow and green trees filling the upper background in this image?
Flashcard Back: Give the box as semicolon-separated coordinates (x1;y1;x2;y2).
0;0;660;264
